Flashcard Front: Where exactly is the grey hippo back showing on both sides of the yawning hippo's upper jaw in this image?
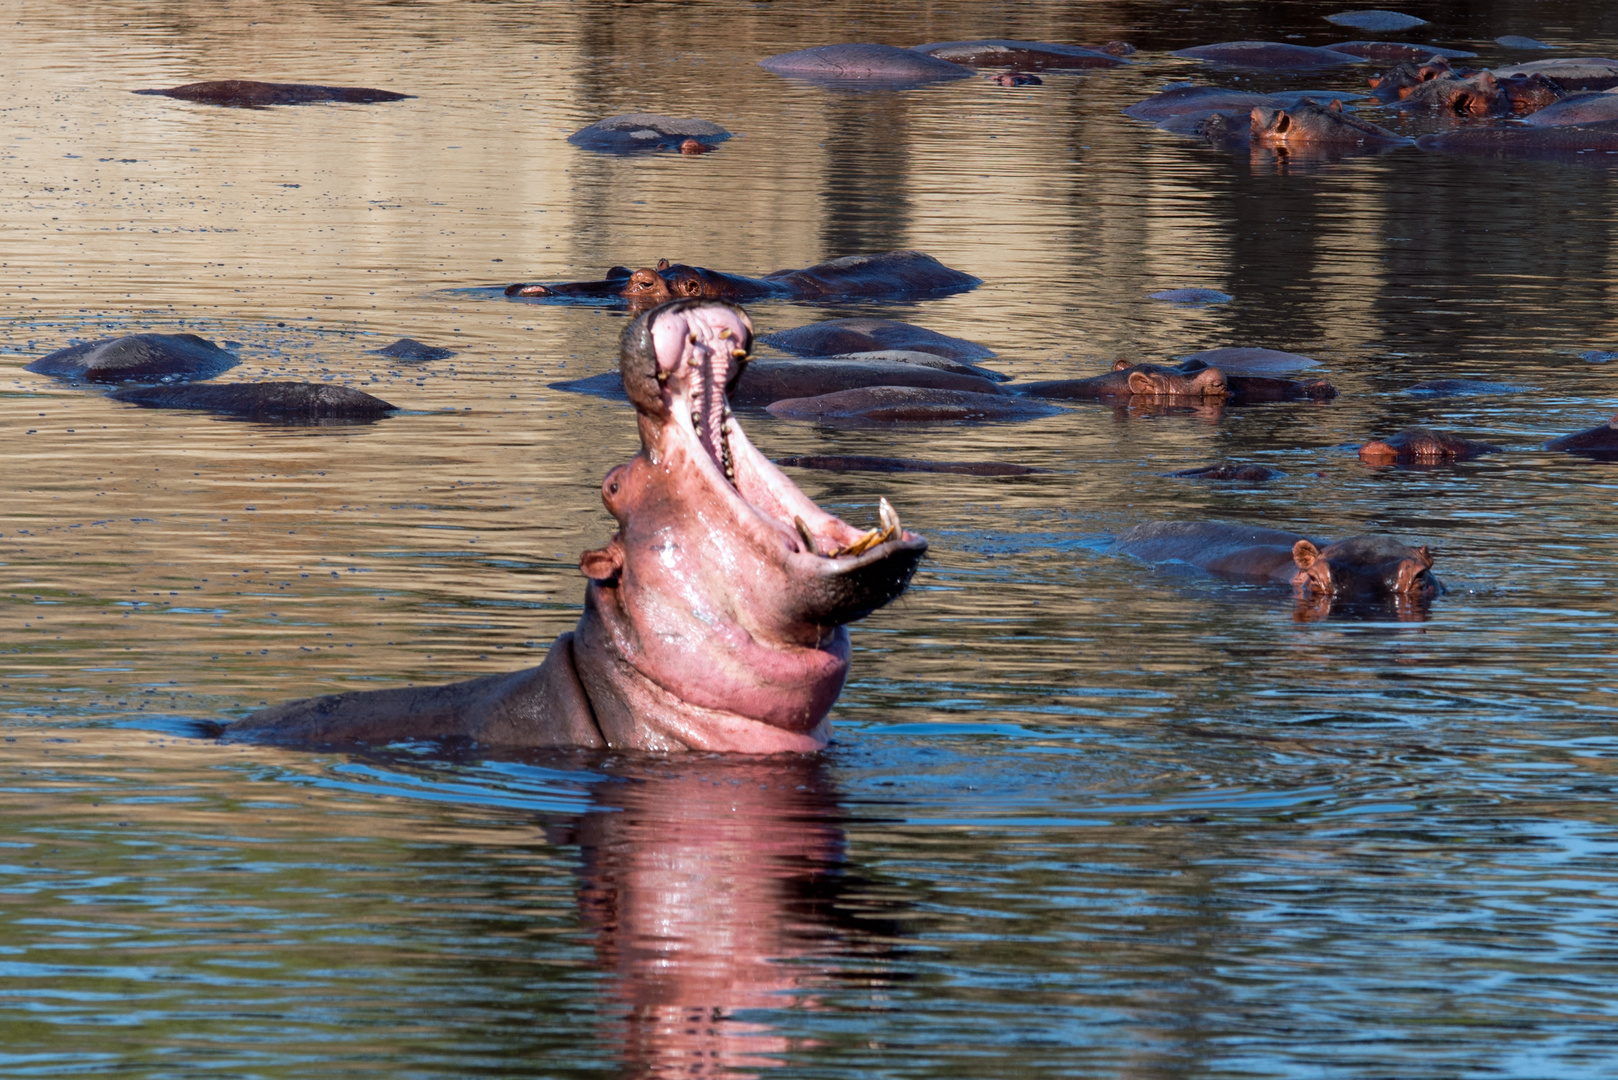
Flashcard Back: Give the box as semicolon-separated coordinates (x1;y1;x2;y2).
550;353;1006;408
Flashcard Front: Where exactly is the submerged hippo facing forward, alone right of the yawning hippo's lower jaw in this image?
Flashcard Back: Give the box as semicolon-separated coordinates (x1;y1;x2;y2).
1113;521;1443;601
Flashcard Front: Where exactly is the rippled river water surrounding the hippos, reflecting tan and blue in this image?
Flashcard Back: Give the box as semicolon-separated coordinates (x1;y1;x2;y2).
0;0;1618;1077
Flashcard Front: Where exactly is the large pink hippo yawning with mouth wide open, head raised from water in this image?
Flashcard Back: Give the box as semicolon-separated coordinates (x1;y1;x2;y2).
225;300;927;753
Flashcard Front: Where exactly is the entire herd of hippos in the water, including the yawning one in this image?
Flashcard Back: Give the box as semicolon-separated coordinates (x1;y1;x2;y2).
29;13;1618;753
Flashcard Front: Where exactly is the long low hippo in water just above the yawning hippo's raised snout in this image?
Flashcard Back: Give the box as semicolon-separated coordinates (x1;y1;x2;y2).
505;251;982;308
